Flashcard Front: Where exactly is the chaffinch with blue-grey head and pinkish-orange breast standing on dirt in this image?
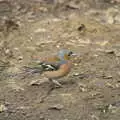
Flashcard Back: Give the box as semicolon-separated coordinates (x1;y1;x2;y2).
23;49;76;87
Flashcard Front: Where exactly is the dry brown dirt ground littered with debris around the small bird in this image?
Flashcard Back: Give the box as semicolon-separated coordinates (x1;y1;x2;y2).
0;0;120;120
